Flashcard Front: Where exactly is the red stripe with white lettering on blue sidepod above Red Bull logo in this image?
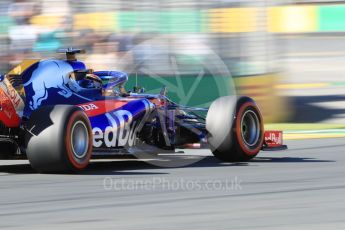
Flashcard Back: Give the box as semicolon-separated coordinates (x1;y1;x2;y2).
78;100;129;117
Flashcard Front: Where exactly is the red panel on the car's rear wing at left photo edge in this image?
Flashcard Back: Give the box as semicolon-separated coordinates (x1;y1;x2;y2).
0;89;20;128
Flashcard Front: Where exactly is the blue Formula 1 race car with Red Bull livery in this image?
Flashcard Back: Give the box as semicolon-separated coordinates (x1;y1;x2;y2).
0;48;285;172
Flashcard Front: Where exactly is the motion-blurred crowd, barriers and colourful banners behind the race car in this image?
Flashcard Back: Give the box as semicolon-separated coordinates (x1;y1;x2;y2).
0;0;345;134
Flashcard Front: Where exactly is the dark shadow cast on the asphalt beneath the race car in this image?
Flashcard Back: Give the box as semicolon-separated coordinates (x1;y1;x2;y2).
0;156;335;175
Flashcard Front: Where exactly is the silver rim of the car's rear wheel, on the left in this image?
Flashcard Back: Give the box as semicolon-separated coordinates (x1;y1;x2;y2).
71;121;89;159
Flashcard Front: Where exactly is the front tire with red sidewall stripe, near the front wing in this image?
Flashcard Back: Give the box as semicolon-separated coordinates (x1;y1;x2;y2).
206;96;264;162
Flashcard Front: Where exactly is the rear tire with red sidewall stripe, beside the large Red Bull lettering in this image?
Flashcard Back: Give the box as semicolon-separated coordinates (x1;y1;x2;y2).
25;105;92;173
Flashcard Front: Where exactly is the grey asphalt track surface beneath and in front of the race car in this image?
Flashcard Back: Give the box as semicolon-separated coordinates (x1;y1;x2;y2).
0;138;345;229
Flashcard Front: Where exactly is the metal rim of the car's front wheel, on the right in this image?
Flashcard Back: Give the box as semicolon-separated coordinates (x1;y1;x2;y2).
241;110;260;147
